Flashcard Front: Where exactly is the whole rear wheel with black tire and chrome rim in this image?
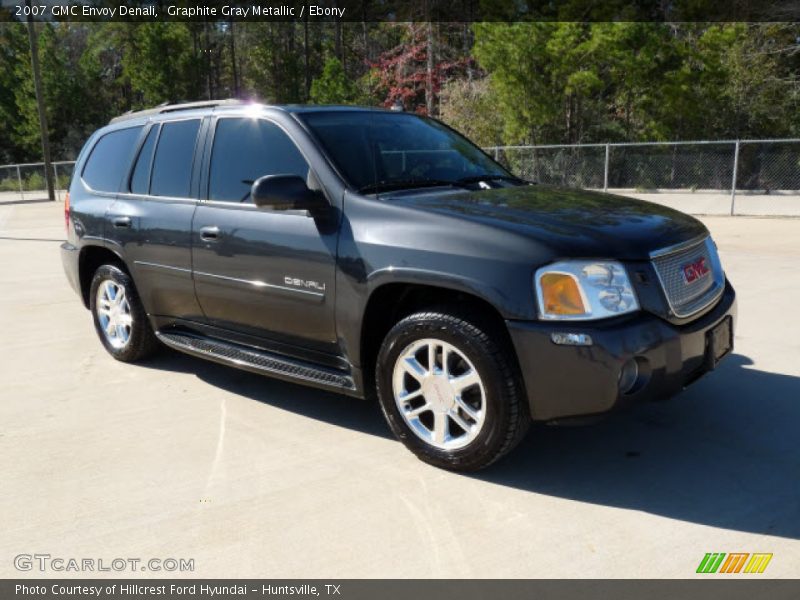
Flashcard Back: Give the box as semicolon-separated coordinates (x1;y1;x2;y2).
89;265;158;362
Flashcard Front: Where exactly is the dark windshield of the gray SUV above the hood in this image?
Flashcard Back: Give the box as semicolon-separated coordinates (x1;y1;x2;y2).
299;111;516;193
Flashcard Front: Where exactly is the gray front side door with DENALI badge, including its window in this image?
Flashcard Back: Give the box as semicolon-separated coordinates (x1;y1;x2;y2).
192;116;338;354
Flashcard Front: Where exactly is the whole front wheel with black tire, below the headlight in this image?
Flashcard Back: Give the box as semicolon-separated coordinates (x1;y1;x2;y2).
375;310;530;471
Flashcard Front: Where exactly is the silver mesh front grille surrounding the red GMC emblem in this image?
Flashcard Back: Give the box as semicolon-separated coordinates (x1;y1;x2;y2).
653;237;725;317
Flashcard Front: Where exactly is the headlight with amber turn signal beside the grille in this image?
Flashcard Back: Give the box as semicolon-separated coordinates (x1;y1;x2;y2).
535;260;639;321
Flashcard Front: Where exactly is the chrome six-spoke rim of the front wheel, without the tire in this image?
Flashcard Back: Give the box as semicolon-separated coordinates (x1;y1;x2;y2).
392;338;486;450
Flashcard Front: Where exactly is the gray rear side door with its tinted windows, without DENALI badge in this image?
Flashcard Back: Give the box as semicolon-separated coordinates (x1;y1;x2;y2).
106;118;202;320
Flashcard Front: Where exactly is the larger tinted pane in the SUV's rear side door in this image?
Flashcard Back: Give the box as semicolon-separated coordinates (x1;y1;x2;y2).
150;120;200;198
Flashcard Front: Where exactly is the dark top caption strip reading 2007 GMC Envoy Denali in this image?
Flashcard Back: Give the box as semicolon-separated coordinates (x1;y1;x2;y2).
0;0;800;22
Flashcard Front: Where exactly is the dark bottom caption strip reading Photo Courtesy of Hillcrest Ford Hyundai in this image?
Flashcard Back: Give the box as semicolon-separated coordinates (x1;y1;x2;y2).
0;574;800;600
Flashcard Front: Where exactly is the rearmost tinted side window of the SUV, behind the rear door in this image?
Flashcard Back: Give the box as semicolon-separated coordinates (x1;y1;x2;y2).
83;127;142;192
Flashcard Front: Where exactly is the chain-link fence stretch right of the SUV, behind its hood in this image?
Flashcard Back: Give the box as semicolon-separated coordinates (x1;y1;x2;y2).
486;139;800;216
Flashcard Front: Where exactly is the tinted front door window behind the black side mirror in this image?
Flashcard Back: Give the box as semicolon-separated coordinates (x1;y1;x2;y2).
209;119;308;202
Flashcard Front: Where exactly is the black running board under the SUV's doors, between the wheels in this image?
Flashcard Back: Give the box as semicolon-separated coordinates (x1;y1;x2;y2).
156;331;356;391
